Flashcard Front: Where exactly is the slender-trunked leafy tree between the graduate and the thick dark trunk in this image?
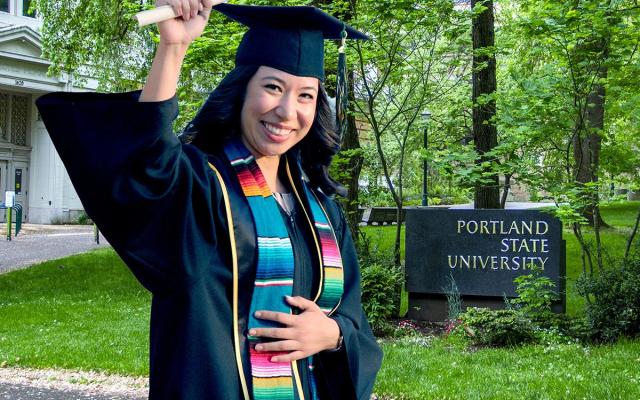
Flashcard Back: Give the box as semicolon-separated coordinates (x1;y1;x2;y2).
355;0;464;264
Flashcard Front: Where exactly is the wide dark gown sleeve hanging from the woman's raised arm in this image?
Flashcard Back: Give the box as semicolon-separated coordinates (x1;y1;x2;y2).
36;92;220;292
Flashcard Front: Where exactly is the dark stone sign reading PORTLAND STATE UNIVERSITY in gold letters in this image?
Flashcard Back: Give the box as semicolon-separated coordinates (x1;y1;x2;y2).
406;209;565;297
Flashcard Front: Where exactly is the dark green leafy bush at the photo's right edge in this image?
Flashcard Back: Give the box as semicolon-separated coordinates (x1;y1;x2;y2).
577;256;640;342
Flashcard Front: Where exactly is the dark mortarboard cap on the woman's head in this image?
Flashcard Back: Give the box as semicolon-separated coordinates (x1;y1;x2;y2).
214;3;368;81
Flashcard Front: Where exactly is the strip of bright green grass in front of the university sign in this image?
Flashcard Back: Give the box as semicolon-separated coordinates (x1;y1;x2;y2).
376;339;640;400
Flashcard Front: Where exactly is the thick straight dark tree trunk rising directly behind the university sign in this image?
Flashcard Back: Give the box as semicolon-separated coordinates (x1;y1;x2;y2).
471;0;500;208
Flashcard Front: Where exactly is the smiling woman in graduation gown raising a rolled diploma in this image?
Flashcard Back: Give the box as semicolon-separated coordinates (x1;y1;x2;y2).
38;0;381;399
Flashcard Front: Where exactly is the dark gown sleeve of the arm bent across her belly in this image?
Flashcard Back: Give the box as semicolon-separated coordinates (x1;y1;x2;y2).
319;203;382;400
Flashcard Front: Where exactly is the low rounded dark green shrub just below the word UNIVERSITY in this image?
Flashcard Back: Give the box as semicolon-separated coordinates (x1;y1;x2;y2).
460;307;535;346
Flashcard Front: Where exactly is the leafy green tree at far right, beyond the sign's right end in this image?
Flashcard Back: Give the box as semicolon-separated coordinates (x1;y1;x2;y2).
502;0;638;274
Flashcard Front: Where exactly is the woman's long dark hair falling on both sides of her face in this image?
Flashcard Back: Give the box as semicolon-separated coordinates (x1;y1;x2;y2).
179;65;346;196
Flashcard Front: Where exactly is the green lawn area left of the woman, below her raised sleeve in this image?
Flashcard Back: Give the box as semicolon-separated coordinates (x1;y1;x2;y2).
0;249;150;375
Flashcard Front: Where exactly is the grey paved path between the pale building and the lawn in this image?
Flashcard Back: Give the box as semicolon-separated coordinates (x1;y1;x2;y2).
0;224;108;274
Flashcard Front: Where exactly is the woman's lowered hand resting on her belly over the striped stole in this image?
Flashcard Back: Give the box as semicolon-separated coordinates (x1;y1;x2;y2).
249;296;340;362
